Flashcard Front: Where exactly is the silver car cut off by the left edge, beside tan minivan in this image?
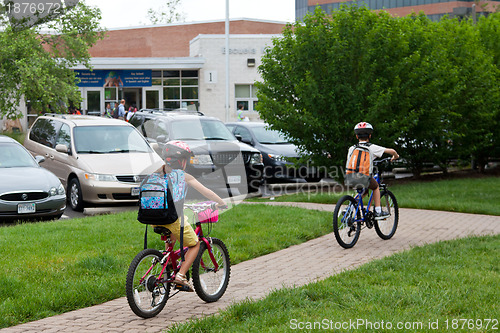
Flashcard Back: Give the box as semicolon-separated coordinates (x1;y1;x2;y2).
0;135;66;220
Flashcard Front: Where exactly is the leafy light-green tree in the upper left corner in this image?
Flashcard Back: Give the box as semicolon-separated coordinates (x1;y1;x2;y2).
0;2;103;119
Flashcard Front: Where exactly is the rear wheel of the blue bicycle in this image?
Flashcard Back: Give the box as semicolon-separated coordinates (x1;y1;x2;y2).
333;195;361;249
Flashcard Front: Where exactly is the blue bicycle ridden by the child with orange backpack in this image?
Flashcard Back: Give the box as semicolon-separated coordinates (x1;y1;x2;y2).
333;157;399;249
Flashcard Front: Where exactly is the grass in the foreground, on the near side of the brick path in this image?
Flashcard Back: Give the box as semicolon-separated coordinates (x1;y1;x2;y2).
169;235;500;333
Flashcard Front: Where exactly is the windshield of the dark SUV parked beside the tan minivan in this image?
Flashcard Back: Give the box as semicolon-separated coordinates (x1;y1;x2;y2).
172;119;236;141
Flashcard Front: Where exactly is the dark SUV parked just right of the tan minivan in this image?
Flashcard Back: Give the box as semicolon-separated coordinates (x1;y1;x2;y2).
129;109;264;195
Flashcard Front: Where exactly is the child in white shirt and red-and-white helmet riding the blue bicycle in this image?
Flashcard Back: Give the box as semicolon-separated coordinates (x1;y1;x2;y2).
346;122;399;220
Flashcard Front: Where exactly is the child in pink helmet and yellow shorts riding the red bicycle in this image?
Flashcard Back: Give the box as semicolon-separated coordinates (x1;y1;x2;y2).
156;141;226;291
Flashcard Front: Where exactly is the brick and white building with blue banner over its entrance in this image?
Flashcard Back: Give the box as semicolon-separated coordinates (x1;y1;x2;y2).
72;19;285;124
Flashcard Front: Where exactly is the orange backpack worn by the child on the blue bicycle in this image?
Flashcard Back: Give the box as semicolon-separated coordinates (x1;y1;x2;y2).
345;144;373;187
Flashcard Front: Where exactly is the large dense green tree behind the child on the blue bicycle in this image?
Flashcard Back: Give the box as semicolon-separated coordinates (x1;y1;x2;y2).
257;5;499;175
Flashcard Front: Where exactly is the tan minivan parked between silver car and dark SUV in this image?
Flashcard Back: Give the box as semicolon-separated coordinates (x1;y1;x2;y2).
24;115;163;211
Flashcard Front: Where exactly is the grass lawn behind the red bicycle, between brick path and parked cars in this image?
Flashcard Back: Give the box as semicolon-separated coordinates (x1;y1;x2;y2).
0;205;331;328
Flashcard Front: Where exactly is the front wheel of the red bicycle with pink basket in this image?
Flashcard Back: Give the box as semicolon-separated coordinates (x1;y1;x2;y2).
193;238;231;303
